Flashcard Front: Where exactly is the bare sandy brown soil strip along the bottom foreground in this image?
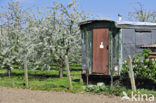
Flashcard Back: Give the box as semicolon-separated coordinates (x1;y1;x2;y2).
0;87;143;103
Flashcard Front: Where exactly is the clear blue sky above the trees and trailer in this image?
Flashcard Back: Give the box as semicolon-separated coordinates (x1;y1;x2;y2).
0;0;156;20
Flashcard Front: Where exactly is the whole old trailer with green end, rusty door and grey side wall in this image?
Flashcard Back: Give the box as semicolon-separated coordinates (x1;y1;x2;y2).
80;20;156;76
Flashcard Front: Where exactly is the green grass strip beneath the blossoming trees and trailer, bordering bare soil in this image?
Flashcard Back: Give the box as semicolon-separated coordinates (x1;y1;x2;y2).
0;66;156;97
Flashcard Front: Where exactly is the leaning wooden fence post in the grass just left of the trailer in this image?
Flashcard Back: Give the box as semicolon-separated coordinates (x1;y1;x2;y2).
65;55;73;91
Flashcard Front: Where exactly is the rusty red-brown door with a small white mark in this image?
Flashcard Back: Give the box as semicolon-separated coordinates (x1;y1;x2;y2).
93;28;109;74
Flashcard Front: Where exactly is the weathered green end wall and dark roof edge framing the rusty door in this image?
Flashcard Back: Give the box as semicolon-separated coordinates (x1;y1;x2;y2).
80;21;121;75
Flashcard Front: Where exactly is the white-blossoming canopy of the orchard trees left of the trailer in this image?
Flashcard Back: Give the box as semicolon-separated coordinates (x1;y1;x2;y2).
0;1;88;76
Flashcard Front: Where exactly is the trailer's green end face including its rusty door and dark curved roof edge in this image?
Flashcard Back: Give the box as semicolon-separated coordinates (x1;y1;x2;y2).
80;20;122;75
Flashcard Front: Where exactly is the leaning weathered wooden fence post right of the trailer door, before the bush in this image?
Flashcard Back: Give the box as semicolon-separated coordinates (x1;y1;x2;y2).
128;56;136;91
